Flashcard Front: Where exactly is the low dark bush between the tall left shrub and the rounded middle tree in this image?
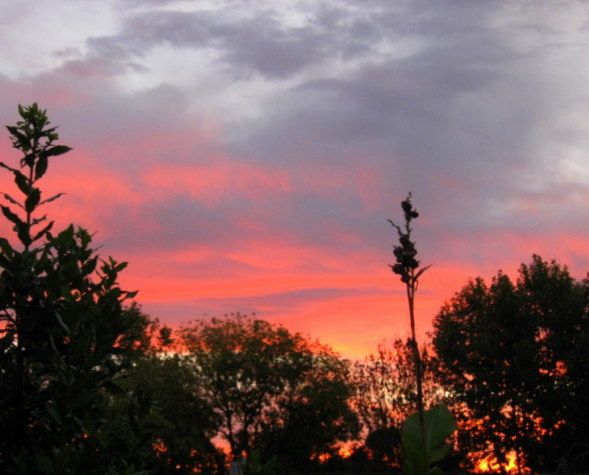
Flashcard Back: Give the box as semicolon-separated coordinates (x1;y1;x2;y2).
103;353;225;475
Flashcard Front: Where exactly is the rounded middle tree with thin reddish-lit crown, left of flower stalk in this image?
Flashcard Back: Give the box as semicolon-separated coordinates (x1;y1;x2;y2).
182;315;358;469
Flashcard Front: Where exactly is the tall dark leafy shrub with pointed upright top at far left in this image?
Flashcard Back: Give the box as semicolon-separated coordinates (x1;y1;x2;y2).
0;104;148;474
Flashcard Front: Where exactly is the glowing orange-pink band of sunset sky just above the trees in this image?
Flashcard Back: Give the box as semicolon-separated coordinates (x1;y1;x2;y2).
0;123;589;360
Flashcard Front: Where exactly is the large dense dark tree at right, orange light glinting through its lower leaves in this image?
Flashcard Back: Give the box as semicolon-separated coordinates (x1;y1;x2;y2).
433;256;589;471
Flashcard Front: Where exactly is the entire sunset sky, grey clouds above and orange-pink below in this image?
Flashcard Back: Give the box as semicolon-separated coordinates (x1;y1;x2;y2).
0;0;589;357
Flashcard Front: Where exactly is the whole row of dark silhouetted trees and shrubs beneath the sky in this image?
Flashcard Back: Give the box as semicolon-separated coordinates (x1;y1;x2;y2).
0;104;589;474
